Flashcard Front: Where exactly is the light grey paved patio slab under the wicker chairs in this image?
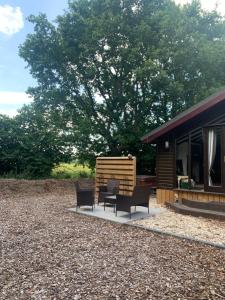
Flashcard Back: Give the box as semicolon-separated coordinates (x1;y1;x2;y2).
69;205;165;223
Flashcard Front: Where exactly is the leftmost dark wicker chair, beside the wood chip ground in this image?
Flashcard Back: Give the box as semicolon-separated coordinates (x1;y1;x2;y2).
75;181;95;211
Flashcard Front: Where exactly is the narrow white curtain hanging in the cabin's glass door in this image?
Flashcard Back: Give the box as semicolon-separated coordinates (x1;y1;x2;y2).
208;129;216;186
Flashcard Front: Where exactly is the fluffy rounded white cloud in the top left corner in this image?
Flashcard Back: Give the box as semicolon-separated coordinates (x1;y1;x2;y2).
0;5;24;35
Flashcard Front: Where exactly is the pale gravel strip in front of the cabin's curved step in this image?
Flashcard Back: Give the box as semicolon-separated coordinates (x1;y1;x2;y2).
133;204;225;246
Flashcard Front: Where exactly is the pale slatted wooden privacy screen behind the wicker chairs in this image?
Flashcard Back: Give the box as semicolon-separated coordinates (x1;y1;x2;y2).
95;157;136;195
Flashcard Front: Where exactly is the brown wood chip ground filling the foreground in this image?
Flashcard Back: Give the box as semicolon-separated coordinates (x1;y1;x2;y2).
0;181;225;300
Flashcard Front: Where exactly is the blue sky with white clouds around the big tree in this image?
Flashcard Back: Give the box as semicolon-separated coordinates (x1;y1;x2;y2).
0;0;225;116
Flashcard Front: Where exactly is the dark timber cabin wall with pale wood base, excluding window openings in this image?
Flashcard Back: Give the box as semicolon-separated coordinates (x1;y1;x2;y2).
154;101;225;205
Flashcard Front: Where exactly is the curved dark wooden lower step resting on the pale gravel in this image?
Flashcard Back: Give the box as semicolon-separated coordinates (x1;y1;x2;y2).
169;203;225;221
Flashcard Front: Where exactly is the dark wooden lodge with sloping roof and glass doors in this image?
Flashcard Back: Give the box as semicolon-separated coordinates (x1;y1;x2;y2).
142;90;225;204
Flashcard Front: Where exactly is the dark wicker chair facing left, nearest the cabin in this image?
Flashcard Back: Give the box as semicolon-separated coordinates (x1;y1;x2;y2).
116;186;152;218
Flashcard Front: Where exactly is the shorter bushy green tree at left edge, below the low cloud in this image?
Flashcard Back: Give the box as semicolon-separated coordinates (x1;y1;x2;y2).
0;105;71;178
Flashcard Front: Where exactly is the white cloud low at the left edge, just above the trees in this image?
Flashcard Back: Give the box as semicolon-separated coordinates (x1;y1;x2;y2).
0;91;33;117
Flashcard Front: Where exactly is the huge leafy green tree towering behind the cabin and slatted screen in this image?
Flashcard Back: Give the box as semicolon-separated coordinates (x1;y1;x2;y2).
20;0;225;172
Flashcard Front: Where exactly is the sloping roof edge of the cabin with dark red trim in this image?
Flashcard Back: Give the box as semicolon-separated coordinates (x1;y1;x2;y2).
141;89;225;143
